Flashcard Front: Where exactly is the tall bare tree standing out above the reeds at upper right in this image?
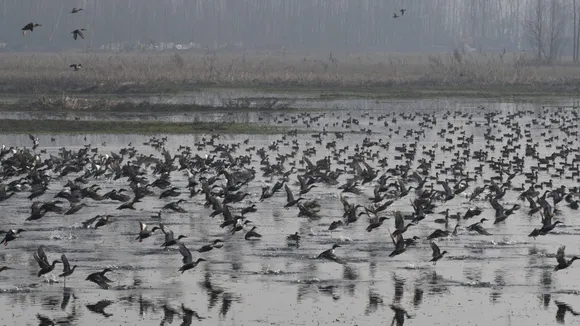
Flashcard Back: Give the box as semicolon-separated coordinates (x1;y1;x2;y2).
524;0;566;63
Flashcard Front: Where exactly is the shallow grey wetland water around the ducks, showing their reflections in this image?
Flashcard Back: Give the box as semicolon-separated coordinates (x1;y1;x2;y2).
0;93;580;325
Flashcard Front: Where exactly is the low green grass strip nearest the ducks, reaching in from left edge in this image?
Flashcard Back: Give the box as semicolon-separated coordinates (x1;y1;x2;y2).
0;119;286;134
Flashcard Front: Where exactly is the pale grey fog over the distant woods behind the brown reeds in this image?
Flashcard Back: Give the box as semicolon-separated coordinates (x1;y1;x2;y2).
0;0;573;53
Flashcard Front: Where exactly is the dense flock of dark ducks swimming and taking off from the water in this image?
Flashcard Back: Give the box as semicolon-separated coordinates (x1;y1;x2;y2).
0;105;580;325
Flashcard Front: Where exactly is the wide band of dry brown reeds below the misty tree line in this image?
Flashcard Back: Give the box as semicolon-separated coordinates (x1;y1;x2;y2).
0;51;580;94
